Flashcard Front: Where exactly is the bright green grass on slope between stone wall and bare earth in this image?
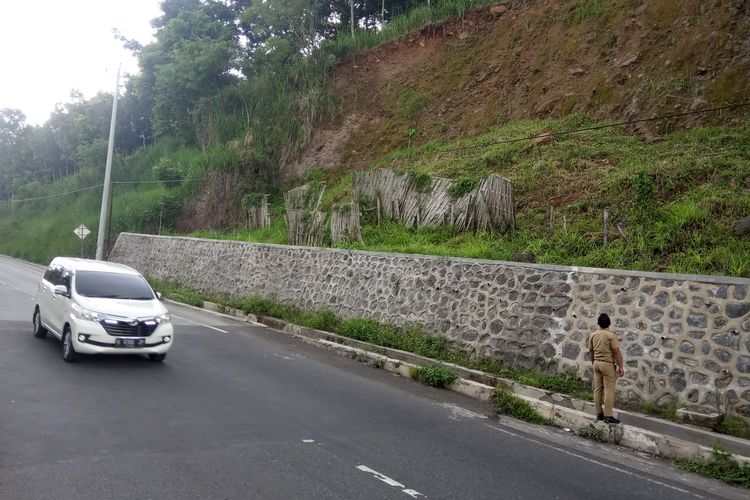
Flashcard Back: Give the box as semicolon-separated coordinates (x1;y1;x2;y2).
148;116;750;277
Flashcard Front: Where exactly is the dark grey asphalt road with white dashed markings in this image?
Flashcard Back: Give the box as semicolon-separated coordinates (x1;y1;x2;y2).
0;257;746;500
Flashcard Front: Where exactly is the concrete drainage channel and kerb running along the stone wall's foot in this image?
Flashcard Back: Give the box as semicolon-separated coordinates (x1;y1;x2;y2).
166;301;750;462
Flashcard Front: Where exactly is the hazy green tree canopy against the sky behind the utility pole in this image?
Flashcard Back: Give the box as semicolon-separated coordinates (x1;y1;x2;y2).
0;0;434;200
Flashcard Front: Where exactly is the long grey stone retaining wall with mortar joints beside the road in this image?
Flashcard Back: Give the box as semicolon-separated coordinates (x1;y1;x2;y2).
110;233;750;417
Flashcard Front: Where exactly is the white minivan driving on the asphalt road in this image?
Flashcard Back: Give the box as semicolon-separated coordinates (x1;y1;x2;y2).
33;257;174;362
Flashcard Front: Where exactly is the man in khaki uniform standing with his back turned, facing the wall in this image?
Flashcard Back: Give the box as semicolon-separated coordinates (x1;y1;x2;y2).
589;314;625;424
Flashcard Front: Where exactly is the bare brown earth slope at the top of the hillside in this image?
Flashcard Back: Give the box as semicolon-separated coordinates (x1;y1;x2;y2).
284;0;750;178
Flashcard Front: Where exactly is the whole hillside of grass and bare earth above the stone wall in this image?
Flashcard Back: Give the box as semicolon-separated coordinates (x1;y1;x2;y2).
0;0;750;277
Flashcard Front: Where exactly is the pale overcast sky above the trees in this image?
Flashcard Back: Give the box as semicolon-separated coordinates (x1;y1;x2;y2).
0;0;161;125
